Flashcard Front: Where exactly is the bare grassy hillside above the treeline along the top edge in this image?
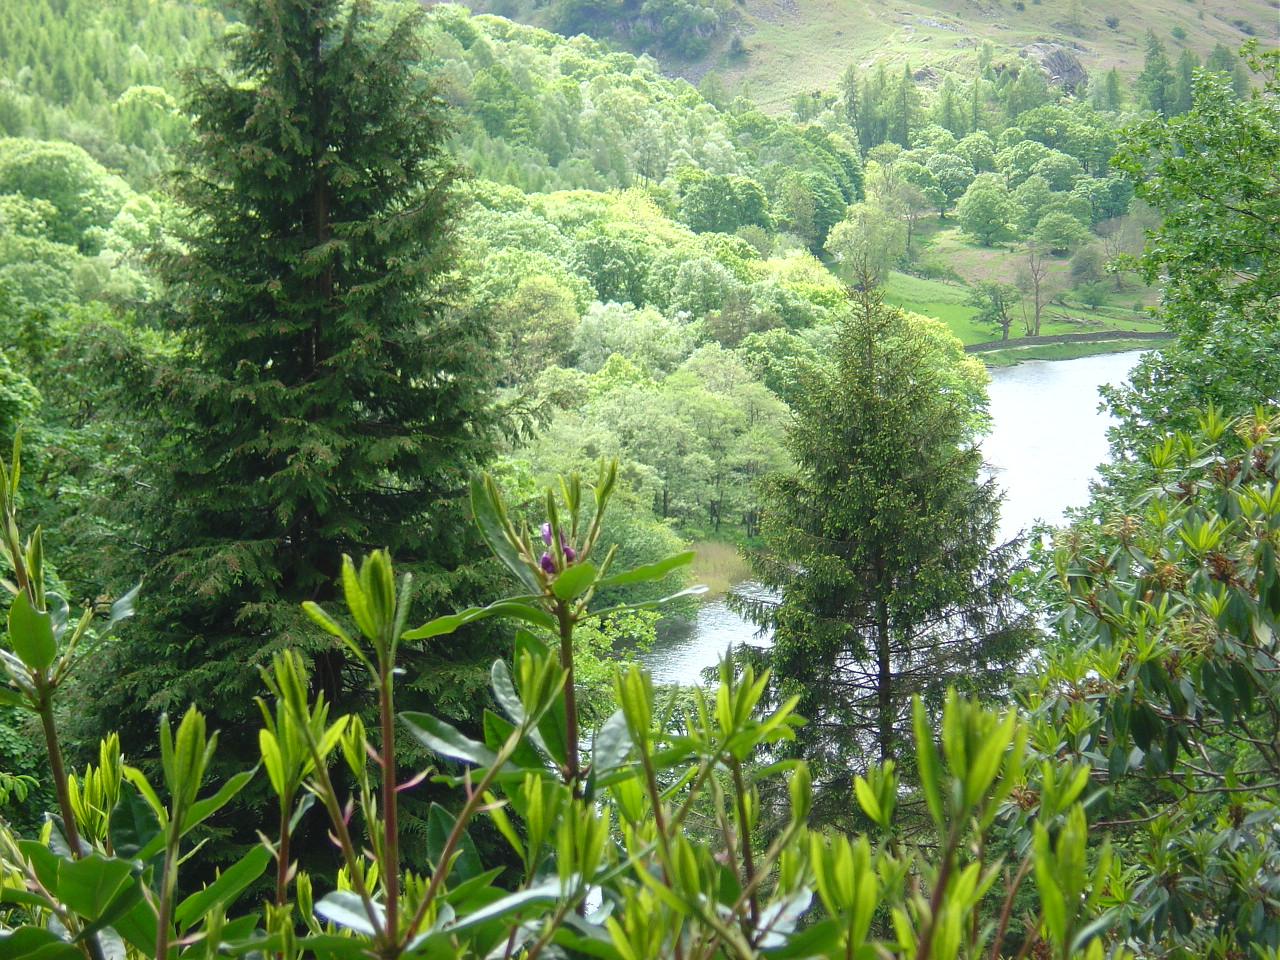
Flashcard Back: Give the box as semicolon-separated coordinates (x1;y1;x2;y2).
472;0;1280;113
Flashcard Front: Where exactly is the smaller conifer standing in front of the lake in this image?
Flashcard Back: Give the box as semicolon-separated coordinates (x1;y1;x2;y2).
751;285;1029;818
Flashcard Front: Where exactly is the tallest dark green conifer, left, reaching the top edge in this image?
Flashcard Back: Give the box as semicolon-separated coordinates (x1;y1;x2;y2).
82;0;492;749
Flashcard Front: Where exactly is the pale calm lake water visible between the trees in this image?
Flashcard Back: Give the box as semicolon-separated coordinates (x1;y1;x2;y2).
644;351;1140;684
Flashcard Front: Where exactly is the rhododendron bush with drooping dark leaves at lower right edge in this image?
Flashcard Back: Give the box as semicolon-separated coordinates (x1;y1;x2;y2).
1032;407;1280;960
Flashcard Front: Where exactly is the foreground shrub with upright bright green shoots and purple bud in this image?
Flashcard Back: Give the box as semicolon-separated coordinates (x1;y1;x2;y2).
0;466;1130;960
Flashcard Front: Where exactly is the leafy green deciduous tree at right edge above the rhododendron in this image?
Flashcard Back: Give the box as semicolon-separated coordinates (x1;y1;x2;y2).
1111;51;1280;451
